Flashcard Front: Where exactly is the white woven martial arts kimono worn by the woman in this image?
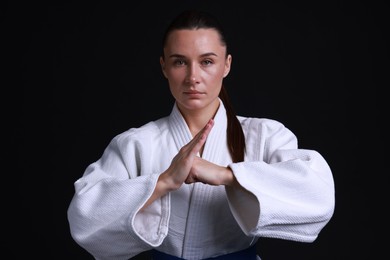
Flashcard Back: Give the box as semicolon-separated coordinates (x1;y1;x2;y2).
68;102;335;260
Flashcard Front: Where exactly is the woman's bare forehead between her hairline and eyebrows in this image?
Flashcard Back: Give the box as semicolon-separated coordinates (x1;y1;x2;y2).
164;29;226;55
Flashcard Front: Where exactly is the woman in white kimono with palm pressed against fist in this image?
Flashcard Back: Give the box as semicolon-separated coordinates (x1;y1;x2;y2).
68;11;335;259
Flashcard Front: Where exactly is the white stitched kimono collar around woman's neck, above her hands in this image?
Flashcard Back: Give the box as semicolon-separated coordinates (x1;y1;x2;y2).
169;100;228;163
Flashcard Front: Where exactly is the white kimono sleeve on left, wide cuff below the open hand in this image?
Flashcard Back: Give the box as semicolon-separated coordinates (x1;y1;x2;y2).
67;129;169;259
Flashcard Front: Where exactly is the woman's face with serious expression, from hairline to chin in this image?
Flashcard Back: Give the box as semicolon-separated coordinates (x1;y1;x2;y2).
160;29;231;112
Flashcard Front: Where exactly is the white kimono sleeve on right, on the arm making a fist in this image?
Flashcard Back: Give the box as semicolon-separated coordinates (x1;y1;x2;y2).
227;120;335;242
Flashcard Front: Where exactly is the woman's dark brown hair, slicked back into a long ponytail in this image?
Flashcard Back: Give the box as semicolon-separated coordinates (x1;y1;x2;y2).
163;10;245;162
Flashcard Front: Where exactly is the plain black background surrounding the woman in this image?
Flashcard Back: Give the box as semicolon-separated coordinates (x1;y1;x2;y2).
6;1;389;260
